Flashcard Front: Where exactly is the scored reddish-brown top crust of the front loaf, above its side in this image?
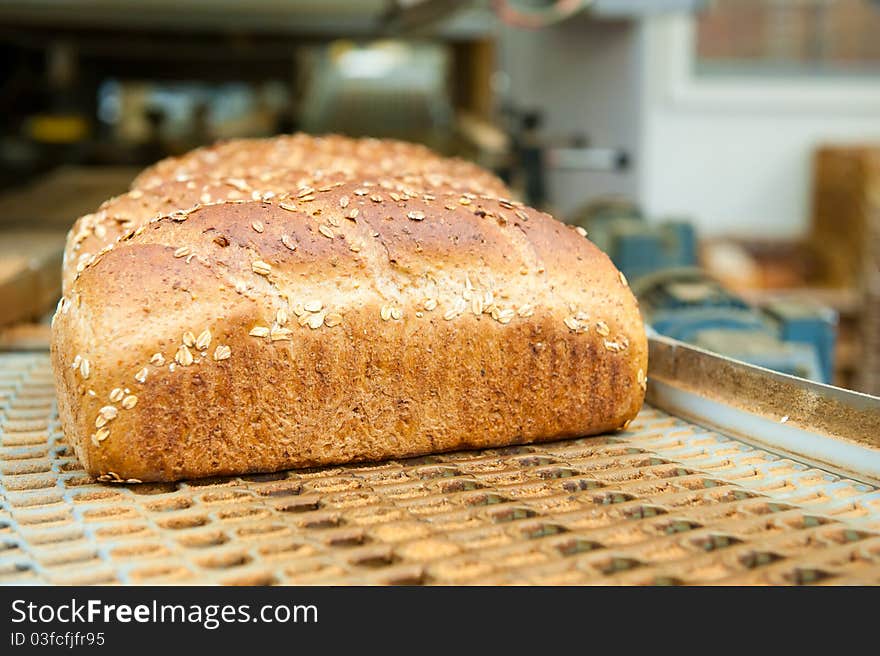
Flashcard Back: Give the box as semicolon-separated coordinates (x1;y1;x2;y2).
65;181;636;344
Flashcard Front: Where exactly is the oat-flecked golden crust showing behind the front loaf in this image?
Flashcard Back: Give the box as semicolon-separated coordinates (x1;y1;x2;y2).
62;134;510;293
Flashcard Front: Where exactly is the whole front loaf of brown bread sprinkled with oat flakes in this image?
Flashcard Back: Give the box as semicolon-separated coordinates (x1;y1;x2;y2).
52;138;647;481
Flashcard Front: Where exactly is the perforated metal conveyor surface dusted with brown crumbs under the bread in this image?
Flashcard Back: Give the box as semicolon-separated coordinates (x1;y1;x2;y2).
0;354;880;584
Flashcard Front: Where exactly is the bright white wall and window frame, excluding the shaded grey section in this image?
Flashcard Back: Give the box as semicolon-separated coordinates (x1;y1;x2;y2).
638;17;880;237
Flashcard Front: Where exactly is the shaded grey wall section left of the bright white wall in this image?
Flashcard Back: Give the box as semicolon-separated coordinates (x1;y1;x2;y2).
498;16;641;216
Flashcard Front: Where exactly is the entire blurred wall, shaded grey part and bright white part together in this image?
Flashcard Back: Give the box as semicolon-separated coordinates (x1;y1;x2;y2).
498;14;880;238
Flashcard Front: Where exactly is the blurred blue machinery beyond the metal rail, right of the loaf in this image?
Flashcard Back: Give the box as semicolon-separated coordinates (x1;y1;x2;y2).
571;198;837;383
